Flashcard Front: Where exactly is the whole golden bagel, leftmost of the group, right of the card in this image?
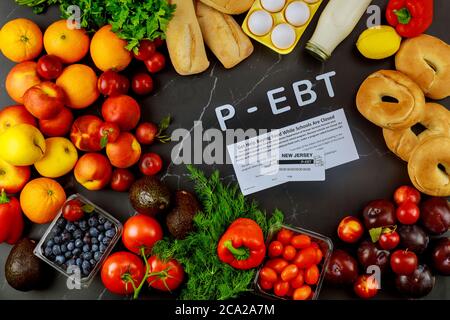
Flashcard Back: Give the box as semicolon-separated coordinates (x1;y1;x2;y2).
356;70;425;130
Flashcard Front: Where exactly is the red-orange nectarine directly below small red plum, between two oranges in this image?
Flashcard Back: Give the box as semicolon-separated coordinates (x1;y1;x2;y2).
23;81;66;120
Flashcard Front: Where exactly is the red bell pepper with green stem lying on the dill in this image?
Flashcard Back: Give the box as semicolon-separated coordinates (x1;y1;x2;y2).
217;218;266;270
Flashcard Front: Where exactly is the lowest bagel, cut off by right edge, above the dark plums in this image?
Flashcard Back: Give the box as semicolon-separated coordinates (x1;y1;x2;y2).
408;135;450;197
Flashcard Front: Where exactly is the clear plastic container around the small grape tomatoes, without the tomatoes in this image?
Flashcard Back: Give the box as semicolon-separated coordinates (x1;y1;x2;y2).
253;225;333;300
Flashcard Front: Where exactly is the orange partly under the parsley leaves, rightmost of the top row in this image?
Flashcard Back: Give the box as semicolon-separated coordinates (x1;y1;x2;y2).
91;25;132;71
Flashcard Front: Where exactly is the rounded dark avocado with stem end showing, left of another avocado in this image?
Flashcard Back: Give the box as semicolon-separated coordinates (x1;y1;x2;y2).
130;176;170;215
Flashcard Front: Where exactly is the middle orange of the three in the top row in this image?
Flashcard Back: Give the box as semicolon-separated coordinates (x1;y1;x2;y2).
44;20;89;64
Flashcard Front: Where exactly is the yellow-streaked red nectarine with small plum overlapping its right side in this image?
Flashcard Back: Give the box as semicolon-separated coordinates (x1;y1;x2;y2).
70;115;103;152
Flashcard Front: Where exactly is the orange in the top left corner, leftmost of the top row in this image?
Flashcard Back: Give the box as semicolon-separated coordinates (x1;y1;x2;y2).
0;19;42;62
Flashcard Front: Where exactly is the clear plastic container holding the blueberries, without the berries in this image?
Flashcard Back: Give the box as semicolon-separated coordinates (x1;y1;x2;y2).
34;194;123;288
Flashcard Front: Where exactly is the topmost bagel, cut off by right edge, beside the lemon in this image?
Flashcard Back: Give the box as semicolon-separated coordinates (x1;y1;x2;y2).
395;34;450;100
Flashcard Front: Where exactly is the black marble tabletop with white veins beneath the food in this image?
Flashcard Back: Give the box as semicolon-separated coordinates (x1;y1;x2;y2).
0;0;450;299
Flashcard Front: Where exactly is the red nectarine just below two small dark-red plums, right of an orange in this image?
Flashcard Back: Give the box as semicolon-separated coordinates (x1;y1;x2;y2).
102;95;141;131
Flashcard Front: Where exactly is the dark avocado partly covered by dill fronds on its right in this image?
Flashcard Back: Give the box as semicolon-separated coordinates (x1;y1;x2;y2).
166;190;201;239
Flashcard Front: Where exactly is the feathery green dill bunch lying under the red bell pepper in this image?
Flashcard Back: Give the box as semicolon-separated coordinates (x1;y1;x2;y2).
152;166;283;300
